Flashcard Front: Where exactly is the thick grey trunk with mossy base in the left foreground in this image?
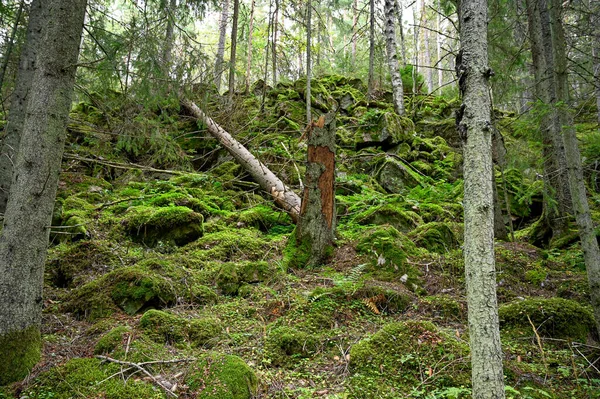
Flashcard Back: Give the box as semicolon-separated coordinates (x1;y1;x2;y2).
0;0;86;384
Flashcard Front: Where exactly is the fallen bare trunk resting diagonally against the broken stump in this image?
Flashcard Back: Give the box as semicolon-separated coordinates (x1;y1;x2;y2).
181;100;302;222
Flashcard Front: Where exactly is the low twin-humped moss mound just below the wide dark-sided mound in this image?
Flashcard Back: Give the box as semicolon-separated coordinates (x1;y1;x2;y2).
140;309;222;345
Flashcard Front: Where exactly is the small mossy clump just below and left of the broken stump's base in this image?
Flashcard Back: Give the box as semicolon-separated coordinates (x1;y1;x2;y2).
216;262;275;295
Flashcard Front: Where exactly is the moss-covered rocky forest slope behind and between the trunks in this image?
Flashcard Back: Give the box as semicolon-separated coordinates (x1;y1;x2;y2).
0;76;600;399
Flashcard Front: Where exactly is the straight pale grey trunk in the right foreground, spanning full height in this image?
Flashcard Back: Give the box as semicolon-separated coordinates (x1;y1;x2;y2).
456;0;504;399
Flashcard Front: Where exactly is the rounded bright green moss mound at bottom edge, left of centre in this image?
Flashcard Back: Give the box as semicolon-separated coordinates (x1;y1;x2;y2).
186;352;258;399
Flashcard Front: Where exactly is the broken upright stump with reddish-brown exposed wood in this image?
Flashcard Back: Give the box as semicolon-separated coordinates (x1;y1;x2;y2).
296;113;336;267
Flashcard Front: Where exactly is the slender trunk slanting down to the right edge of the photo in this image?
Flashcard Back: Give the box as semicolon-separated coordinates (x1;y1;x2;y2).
549;0;600;331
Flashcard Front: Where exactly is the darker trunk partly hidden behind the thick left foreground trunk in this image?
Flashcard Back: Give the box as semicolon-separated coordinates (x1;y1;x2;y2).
0;0;45;214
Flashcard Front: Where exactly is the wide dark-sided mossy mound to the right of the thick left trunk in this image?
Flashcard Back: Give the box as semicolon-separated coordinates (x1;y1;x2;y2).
63;267;175;321
